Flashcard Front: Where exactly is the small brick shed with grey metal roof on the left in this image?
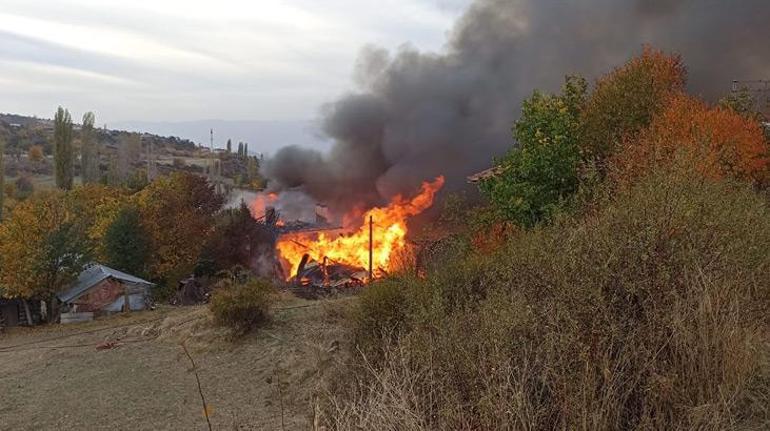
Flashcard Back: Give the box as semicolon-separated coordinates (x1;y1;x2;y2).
57;264;154;314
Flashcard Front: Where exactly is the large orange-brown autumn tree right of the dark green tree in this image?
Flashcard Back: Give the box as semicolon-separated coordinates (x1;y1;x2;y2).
136;172;224;285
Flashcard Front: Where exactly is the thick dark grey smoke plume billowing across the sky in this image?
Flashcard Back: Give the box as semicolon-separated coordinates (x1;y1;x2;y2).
263;0;770;215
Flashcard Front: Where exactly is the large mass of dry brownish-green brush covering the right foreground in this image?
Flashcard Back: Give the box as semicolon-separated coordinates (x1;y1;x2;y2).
329;173;770;429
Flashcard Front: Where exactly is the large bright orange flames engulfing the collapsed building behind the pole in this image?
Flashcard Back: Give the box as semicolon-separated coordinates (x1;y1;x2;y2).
276;177;444;278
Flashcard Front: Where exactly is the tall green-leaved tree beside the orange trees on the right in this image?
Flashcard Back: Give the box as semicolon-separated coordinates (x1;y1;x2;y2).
481;77;587;227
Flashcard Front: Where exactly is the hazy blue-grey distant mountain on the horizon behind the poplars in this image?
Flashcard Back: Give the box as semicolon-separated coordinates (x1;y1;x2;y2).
108;120;331;155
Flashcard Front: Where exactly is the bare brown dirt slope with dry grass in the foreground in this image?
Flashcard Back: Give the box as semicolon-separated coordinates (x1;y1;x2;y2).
0;297;353;430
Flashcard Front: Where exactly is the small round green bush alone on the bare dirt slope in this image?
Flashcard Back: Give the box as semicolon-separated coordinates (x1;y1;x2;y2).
209;280;274;335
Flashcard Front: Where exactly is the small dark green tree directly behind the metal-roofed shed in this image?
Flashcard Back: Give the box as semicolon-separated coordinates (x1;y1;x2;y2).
103;207;150;276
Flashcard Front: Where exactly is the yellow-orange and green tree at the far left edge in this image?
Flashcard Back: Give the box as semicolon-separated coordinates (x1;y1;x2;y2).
0;192;91;319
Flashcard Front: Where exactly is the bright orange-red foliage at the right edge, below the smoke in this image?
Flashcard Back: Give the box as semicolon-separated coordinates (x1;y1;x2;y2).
611;93;768;184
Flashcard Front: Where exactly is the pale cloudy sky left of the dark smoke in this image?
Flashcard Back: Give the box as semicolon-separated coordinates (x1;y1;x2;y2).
0;0;470;125
